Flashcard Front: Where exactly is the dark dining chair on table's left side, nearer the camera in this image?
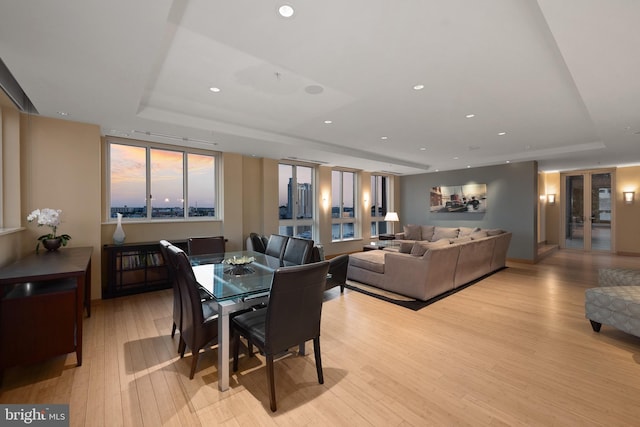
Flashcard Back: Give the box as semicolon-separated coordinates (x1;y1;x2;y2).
167;246;218;379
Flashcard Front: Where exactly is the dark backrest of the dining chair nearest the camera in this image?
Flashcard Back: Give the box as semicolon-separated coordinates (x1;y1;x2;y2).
264;261;329;354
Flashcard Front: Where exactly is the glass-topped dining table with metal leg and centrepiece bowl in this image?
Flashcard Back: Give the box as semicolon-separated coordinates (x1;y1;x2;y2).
189;251;280;391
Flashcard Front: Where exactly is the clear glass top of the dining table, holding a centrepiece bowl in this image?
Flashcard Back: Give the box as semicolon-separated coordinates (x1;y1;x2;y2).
189;251;279;301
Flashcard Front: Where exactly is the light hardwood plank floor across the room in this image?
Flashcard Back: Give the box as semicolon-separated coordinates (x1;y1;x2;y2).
0;251;640;427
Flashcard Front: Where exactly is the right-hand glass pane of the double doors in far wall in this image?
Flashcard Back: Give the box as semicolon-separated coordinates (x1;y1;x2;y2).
591;173;611;251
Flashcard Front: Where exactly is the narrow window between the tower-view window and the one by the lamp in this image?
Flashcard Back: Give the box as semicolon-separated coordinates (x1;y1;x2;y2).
331;170;356;241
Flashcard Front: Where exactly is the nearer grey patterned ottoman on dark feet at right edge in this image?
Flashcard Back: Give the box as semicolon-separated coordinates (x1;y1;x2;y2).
585;286;640;337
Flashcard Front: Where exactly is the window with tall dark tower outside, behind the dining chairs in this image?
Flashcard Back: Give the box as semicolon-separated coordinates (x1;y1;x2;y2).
278;164;315;239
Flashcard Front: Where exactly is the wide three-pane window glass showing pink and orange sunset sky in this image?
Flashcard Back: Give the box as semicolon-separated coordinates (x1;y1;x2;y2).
107;141;218;220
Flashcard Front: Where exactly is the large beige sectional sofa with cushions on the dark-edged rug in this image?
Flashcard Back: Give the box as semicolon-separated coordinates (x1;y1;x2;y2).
347;225;511;301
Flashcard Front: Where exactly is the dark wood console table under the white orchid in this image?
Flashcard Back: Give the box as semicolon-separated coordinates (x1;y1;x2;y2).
0;247;93;381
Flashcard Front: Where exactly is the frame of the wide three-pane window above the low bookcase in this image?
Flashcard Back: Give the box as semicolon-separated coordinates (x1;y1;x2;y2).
104;137;222;223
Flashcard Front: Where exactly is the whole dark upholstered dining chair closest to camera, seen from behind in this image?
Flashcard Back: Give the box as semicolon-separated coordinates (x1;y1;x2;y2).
231;261;329;412
